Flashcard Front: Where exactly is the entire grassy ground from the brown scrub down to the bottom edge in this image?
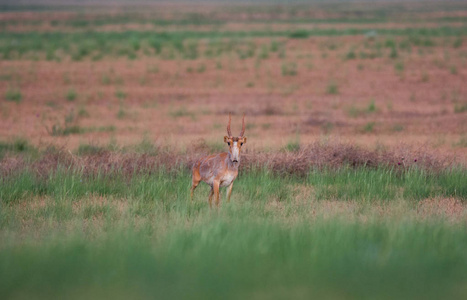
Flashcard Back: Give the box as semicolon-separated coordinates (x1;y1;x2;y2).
0;167;467;299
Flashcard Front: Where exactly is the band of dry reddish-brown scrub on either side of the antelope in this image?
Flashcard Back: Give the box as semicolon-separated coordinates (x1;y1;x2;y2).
0;142;456;177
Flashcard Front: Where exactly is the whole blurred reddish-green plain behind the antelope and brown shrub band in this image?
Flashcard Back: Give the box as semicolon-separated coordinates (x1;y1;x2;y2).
0;0;467;160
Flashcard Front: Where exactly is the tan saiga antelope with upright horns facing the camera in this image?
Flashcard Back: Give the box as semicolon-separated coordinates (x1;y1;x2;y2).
191;114;246;207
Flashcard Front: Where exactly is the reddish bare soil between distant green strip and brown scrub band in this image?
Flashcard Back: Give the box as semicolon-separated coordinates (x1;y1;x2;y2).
0;4;467;160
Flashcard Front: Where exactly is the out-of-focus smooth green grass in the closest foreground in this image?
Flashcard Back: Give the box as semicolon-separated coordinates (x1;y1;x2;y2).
0;214;466;299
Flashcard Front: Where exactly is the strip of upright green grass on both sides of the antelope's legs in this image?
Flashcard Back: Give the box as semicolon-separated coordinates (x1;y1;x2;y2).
0;165;467;207
